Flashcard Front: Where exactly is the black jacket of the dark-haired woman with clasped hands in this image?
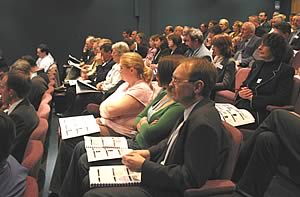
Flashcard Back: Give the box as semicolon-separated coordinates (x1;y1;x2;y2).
236;61;295;123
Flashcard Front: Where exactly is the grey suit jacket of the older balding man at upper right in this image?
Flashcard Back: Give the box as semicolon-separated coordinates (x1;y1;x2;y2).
234;36;261;67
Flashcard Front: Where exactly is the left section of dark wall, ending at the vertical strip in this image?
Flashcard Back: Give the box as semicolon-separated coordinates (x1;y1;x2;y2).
0;0;137;64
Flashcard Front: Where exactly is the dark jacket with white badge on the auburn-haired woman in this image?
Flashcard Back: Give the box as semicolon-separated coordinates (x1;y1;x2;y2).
214;58;235;91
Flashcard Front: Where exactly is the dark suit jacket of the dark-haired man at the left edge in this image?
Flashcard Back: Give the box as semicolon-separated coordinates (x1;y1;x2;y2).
9;98;39;163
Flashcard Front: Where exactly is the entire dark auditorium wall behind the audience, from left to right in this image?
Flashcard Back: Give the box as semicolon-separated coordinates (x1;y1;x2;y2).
0;0;291;65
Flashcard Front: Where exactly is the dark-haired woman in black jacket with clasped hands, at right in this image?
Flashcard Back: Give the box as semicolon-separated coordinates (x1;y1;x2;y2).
235;33;295;128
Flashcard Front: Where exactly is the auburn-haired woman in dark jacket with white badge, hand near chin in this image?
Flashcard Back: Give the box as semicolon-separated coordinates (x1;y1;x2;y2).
211;34;235;98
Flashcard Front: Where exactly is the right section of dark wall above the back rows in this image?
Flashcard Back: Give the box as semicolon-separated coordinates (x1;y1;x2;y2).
151;0;291;33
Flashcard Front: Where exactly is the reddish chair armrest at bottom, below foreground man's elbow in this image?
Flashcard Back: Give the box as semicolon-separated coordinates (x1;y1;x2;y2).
184;180;235;197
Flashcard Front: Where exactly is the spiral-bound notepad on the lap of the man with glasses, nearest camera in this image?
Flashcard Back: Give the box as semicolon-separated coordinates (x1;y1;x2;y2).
89;165;141;188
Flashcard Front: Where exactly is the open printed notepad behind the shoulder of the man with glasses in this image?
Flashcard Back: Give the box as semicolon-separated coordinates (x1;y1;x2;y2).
215;103;255;127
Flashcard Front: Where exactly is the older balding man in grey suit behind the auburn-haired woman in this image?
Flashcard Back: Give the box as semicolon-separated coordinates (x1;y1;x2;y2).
234;22;261;67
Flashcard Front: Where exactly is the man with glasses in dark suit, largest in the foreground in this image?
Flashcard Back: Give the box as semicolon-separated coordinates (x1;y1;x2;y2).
84;58;230;197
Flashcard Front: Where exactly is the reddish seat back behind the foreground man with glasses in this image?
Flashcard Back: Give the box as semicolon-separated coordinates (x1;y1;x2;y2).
220;121;243;179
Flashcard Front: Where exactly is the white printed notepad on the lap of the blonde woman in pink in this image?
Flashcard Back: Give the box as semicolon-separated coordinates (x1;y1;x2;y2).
58;115;100;140
